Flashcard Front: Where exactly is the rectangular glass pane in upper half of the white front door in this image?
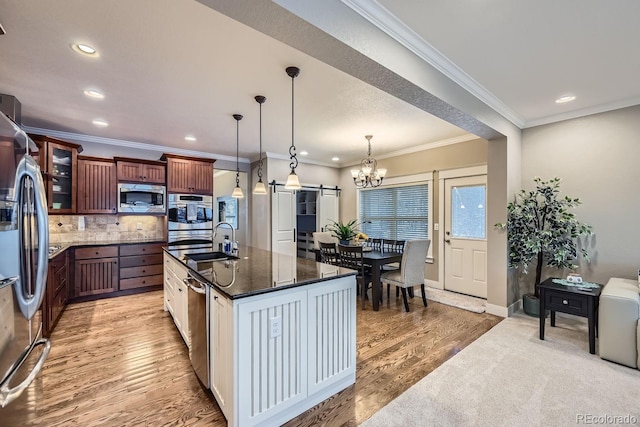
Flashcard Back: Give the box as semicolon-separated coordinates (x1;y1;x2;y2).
451;185;487;239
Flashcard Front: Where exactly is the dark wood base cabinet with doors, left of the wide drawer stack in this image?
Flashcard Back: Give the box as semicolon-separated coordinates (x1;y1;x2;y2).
73;246;119;298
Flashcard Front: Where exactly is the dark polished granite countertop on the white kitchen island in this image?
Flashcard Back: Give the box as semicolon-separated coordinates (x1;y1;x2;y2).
165;246;356;299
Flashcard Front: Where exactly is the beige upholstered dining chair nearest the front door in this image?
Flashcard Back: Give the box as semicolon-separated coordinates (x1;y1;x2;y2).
380;239;431;312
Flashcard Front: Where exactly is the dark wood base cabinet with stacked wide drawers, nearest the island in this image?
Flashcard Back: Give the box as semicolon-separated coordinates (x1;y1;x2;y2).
120;243;163;290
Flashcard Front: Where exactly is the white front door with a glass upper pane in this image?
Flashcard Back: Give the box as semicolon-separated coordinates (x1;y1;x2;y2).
444;175;487;298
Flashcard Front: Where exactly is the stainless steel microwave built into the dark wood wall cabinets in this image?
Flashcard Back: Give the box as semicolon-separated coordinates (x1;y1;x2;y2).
118;183;167;214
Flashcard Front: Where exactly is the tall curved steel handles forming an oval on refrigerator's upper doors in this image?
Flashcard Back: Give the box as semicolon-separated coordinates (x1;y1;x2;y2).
14;154;49;320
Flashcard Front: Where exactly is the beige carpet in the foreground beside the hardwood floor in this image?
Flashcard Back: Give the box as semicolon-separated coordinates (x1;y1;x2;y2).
362;313;640;427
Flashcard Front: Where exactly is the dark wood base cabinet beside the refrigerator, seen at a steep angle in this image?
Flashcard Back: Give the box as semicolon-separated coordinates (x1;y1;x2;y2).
42;251;69;337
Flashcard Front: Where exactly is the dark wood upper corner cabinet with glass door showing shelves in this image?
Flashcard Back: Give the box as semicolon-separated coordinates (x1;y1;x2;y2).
29;134;82;214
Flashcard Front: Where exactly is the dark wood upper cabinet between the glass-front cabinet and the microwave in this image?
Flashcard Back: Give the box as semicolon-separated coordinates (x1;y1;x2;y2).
77;156;118;214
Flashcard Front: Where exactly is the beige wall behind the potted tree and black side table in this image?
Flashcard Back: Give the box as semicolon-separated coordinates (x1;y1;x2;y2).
522;106;640;283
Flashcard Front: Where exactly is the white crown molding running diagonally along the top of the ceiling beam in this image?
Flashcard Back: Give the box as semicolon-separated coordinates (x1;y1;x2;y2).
341;0;525;128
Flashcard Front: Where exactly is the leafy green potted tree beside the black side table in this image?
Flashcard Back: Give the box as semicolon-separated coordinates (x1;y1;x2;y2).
496;177;592;316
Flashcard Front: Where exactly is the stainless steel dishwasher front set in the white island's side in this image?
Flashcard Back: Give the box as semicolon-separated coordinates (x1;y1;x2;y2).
184;274;210;389
